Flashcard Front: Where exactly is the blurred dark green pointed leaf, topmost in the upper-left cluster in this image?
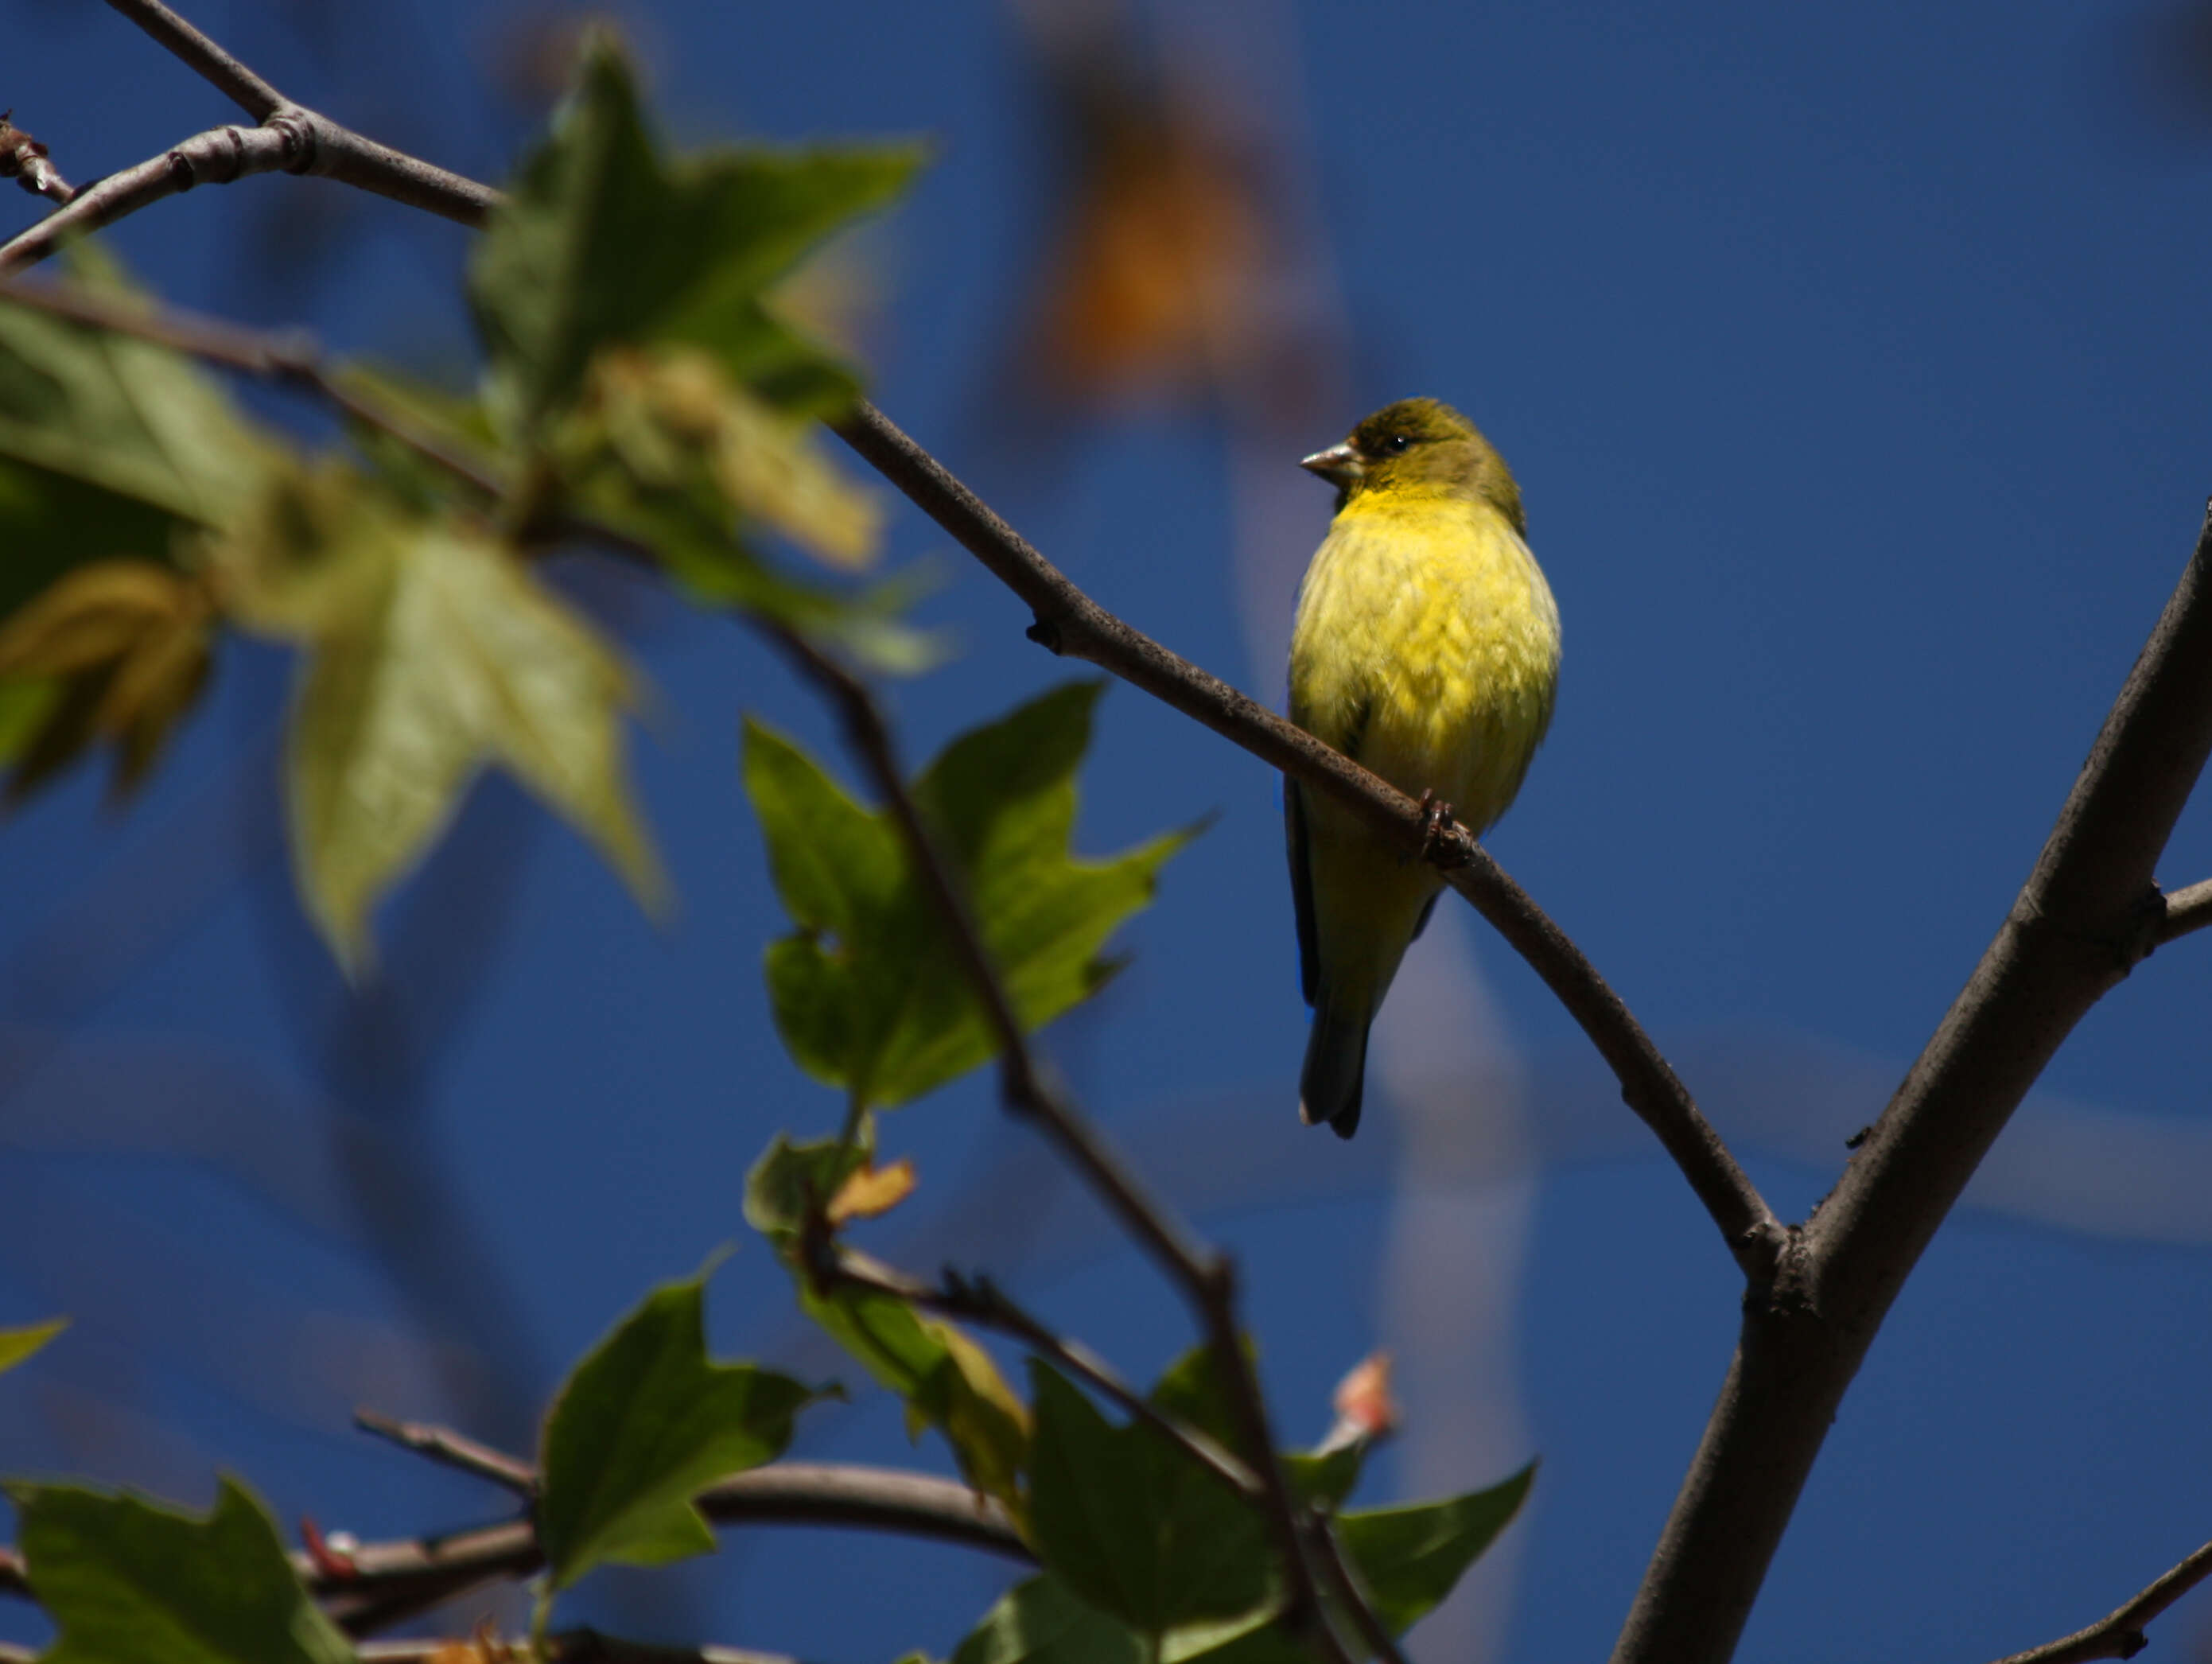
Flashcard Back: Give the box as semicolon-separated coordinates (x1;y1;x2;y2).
469;36;920;436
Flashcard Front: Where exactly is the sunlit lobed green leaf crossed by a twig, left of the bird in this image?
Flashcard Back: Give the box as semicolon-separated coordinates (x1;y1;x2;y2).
745;682;1195;1106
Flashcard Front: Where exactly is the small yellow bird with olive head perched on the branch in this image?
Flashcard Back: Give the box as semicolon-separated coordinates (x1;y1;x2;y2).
1283;399;1560;1137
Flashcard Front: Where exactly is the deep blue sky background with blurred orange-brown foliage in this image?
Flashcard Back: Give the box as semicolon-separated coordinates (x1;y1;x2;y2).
0;0;2212;1659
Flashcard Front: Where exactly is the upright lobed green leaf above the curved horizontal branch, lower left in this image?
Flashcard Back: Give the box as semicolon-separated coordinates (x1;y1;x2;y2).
538;1279;818;1588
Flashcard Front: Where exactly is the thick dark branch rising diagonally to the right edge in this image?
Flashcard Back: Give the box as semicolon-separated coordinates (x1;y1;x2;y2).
1615;515;2212;1664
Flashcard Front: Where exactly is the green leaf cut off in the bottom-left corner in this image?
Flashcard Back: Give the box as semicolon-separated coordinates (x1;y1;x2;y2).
6;1478;354;1664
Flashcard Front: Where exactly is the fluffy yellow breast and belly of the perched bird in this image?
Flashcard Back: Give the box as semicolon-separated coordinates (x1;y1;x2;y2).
1289;493;1560;832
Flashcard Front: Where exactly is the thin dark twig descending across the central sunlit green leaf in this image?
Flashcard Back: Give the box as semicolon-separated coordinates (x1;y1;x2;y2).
756;620;1349;1664
